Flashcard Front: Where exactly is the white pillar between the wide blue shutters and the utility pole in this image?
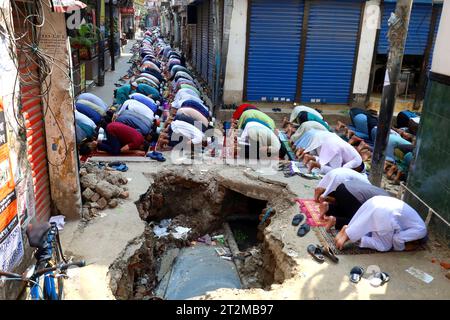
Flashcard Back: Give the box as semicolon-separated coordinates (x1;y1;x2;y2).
352;0;380;106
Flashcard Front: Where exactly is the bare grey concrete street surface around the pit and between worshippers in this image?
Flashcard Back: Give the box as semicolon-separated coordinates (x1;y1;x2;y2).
55;37;450;300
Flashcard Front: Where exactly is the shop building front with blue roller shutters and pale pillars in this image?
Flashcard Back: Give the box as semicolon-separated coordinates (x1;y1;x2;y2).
164;0;442;106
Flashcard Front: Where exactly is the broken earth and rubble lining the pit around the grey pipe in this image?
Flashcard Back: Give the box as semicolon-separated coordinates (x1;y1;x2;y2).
110;169;295;300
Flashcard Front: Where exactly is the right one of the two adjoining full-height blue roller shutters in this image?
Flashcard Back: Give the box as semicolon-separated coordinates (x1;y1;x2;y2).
301;0;361;103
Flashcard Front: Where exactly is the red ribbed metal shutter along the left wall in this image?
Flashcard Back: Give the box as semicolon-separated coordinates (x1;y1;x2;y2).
14;6;51;221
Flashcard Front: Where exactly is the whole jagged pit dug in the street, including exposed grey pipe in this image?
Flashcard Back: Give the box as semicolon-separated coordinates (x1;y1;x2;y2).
109;169;295;300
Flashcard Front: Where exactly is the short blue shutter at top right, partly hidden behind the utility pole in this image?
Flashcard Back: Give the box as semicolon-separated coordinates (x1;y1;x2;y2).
377;3;431;55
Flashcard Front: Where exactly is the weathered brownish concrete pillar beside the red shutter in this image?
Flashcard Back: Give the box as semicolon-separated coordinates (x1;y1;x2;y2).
39;0;81;219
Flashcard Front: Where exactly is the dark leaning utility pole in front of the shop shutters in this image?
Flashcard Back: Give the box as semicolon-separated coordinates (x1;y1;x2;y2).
370;0;413;186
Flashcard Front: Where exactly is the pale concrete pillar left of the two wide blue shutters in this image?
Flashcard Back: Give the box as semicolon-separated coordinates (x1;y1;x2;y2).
223;0;248;104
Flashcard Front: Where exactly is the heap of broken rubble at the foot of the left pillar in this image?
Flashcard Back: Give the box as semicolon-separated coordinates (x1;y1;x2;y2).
80;162;129;222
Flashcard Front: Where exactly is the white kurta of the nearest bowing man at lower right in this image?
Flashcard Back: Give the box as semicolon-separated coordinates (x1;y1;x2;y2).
346;196;427;251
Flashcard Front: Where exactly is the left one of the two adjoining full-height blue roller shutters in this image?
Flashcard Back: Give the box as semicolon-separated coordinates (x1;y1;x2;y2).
245;0;304;101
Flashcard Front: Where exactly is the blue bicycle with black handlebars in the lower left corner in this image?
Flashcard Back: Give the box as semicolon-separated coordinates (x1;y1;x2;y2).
0;222;86;300
